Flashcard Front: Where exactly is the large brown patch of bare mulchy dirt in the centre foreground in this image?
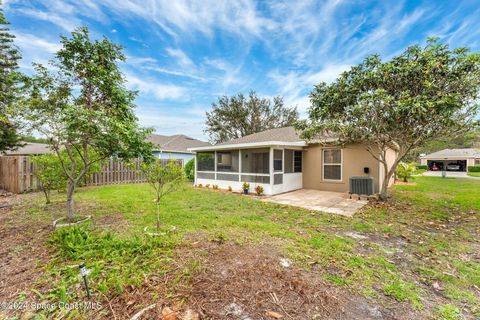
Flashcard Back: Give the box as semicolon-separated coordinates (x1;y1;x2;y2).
104;241;418;320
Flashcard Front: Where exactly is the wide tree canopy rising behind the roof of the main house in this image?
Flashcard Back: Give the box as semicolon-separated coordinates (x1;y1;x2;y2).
205;91;298;143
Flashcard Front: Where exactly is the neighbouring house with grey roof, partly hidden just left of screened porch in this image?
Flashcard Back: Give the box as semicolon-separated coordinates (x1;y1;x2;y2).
149;134;210;164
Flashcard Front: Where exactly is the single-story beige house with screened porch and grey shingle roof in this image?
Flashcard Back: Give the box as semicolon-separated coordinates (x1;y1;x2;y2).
189;127;395;195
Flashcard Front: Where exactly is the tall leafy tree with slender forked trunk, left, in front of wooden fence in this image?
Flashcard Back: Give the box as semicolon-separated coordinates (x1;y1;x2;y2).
18;27;152;220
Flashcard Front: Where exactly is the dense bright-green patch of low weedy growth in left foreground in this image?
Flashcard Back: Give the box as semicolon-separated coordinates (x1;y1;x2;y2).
45;226;176;302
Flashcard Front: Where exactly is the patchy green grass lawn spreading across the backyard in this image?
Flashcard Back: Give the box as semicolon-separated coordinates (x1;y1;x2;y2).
0;177;480;319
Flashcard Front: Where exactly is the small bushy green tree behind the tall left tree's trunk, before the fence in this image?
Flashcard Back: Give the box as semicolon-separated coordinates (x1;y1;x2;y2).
31;151;102;204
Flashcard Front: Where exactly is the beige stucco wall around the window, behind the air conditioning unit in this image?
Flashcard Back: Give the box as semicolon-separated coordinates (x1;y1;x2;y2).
303;144;395;193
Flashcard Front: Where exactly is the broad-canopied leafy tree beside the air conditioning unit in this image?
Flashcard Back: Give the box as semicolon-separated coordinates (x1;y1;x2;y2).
299;39;480;200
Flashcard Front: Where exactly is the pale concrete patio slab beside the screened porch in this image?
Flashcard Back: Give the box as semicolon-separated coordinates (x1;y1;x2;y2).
264;189;368;217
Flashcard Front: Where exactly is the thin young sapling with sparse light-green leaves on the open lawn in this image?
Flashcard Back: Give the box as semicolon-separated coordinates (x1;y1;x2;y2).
141;160;185;230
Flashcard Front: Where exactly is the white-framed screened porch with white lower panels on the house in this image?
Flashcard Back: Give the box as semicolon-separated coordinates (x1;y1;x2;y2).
195;147;303;194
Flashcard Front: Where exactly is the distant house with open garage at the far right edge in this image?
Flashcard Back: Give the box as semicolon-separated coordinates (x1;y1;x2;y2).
420;148;480;171
